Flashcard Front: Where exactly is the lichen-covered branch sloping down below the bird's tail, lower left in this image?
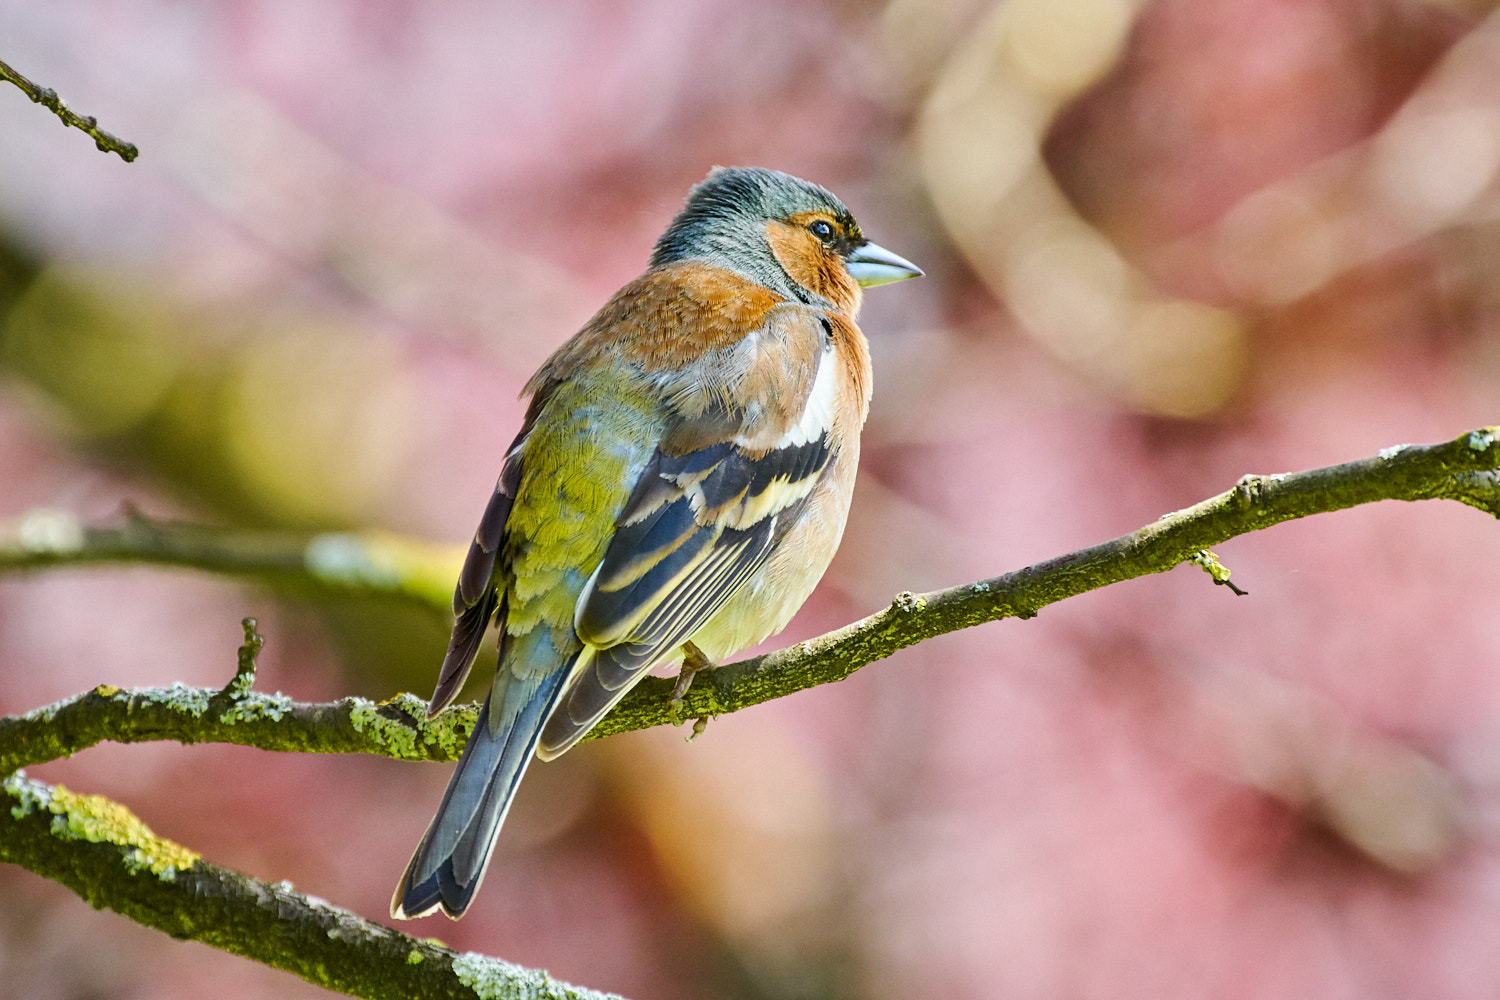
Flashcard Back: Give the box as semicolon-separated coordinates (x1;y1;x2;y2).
0;774;618;1000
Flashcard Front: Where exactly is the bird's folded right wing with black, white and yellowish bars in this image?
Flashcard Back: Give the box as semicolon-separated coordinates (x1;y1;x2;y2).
537;306;840;759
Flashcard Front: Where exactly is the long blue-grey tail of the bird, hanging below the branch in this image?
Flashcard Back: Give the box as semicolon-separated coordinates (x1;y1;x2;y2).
390;664;569;921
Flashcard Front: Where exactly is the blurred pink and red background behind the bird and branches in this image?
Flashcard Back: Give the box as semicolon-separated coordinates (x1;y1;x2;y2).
0;0;1500;1000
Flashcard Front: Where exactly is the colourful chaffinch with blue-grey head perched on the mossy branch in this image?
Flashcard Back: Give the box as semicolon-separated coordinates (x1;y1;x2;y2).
392;166;923;919
